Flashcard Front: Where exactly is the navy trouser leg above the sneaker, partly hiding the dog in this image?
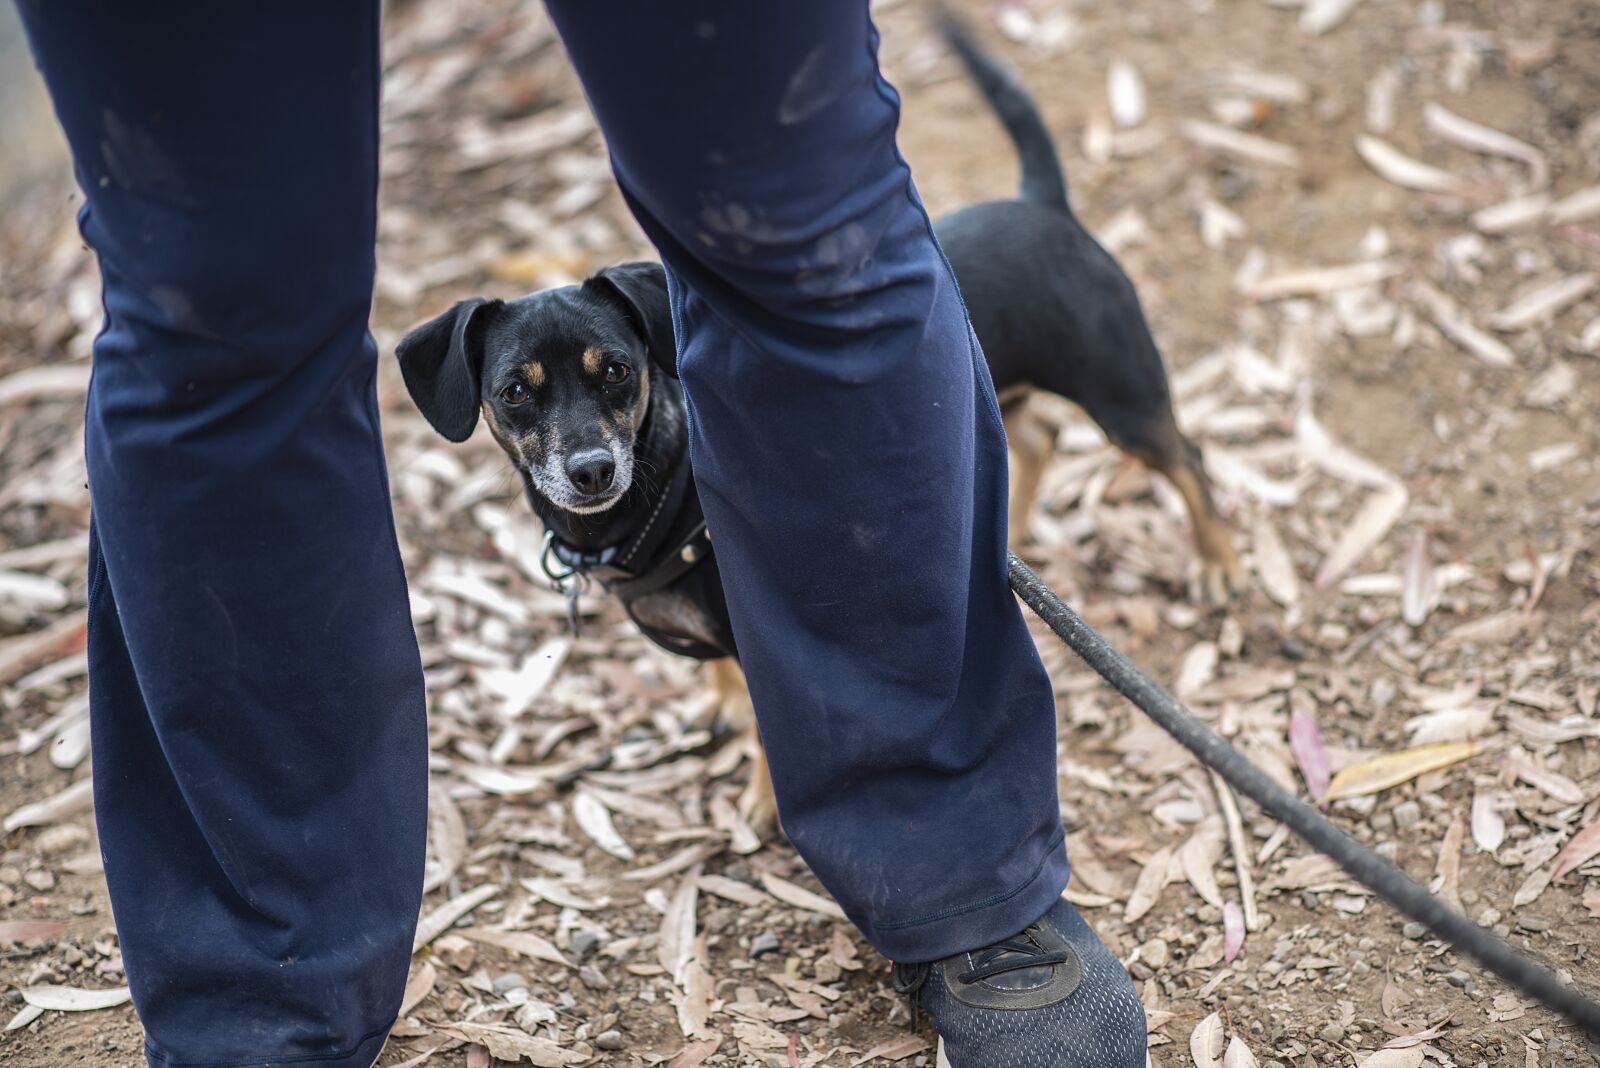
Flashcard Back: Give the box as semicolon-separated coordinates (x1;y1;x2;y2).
549;0;1067;961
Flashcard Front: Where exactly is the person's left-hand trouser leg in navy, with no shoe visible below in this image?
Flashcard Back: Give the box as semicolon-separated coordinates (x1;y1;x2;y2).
21;0;427;1068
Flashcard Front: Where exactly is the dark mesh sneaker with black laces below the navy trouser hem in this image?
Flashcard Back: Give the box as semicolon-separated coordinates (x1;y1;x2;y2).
893;900;1146;1068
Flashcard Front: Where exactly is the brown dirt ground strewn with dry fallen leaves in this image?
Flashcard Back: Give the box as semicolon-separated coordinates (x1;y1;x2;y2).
0;0;1600;1068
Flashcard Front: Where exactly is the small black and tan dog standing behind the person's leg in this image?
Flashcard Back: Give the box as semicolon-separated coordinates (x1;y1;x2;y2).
397;18;1238;833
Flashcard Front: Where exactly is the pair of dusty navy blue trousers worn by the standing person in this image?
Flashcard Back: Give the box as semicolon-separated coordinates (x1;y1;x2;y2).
21;0;1067;1068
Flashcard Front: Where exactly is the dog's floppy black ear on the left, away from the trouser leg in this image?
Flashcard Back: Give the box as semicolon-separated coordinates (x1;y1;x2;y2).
395;297;501;441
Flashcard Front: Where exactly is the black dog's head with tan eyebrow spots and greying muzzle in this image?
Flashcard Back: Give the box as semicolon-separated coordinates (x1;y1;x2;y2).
395;264;677;513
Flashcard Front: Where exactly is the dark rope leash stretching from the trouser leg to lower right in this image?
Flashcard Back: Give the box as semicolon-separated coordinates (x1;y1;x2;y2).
1008;553;1600;1036
